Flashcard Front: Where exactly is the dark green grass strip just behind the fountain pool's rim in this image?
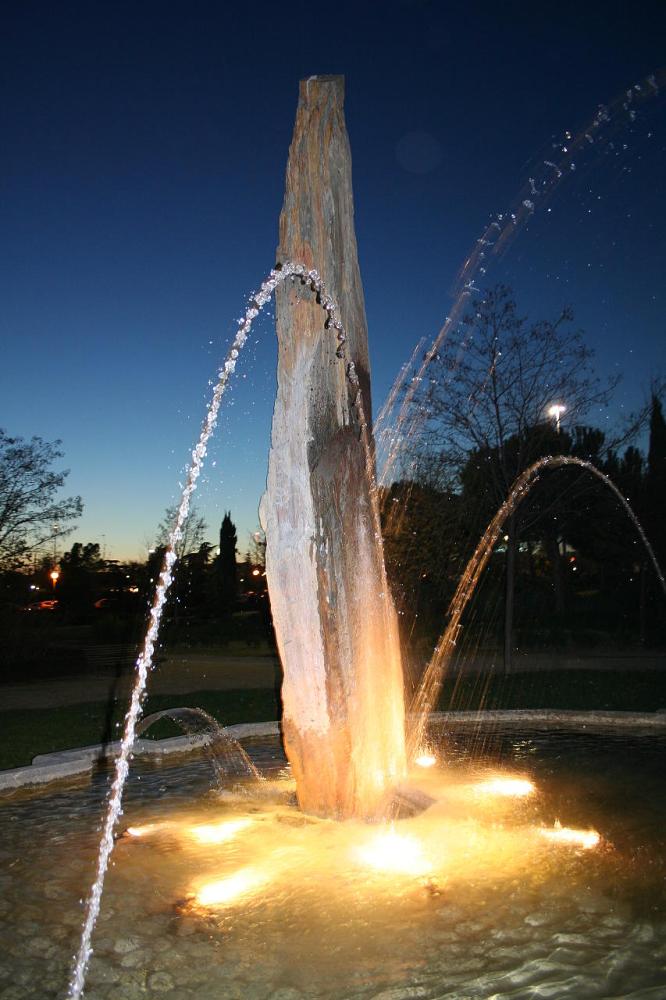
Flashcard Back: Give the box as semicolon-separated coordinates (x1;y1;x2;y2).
0;670;666;769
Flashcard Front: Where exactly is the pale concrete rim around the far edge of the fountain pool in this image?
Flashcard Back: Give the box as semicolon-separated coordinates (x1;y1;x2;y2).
0;709;666;793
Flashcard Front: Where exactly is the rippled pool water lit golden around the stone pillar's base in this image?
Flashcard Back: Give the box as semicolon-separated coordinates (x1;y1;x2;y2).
0;727;666;1000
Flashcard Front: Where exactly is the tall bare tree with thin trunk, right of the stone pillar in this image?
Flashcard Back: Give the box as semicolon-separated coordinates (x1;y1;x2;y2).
410;285;618;669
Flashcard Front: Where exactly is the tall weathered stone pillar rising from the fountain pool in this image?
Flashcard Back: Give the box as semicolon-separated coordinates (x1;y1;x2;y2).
261;77;405;817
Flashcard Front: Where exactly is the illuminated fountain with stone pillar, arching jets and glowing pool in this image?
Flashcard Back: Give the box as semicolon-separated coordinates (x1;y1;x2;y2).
0;77;666;1000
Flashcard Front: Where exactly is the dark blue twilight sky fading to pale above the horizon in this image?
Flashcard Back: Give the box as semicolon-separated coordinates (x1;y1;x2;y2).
0;0;666;558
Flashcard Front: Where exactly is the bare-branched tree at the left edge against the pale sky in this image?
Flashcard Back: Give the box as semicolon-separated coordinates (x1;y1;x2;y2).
0;429;83;569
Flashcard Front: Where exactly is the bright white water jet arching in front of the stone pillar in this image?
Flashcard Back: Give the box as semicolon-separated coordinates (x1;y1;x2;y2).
68;261;364;1000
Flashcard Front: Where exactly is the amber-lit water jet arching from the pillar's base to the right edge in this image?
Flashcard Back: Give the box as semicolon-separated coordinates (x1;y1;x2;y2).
407;455;666;760
